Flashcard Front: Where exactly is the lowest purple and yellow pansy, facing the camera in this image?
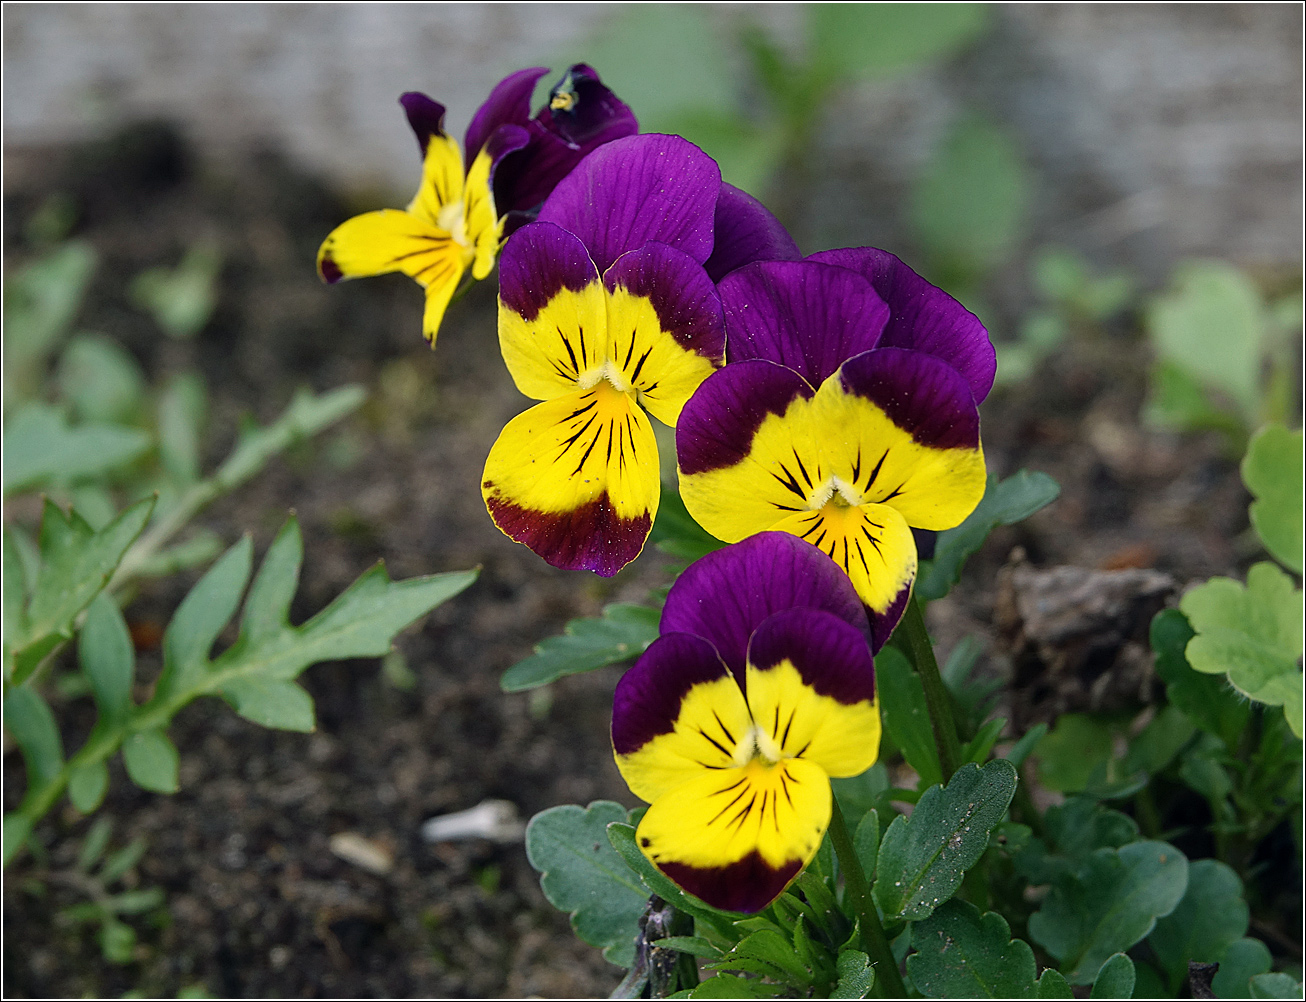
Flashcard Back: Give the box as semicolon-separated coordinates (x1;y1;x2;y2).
613;533;880;912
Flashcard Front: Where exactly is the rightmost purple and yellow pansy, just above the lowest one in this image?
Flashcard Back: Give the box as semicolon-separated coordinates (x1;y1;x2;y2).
677;258;994;649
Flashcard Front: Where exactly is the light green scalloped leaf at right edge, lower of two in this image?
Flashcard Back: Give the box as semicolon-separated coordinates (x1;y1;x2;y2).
1179;562;1302;737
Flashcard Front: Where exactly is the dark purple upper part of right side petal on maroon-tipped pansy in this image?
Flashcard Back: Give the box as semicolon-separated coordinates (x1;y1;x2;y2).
603;243;726;363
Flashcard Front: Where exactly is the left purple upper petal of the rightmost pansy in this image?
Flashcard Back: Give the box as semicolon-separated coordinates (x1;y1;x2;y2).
720;261;889;387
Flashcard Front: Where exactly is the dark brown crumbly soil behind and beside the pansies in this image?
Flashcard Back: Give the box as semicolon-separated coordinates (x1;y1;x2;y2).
3;127;1295;997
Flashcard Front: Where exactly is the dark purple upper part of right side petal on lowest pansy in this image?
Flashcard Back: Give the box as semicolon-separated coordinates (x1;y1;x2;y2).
748;609;875;705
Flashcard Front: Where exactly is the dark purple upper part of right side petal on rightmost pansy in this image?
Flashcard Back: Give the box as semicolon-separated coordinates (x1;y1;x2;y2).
835;347;980;449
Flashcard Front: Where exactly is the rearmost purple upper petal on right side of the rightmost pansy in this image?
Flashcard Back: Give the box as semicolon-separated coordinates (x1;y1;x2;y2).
807;247;998;404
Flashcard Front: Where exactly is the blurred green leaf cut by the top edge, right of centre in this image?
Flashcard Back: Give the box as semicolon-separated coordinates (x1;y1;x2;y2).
803;4;990;80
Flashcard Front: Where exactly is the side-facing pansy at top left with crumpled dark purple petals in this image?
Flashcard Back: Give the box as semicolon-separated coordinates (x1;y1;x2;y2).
317;64;639;345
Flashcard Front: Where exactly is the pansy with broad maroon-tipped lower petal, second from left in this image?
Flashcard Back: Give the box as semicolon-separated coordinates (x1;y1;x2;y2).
482;135;725;576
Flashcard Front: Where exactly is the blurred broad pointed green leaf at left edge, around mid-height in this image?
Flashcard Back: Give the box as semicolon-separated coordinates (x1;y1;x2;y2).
3;404;150;498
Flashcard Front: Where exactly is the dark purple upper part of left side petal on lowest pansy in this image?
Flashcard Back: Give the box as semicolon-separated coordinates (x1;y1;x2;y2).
613;634;730;755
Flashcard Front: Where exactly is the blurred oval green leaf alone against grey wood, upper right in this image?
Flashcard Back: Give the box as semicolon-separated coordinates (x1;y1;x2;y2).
910;113;1032;277
